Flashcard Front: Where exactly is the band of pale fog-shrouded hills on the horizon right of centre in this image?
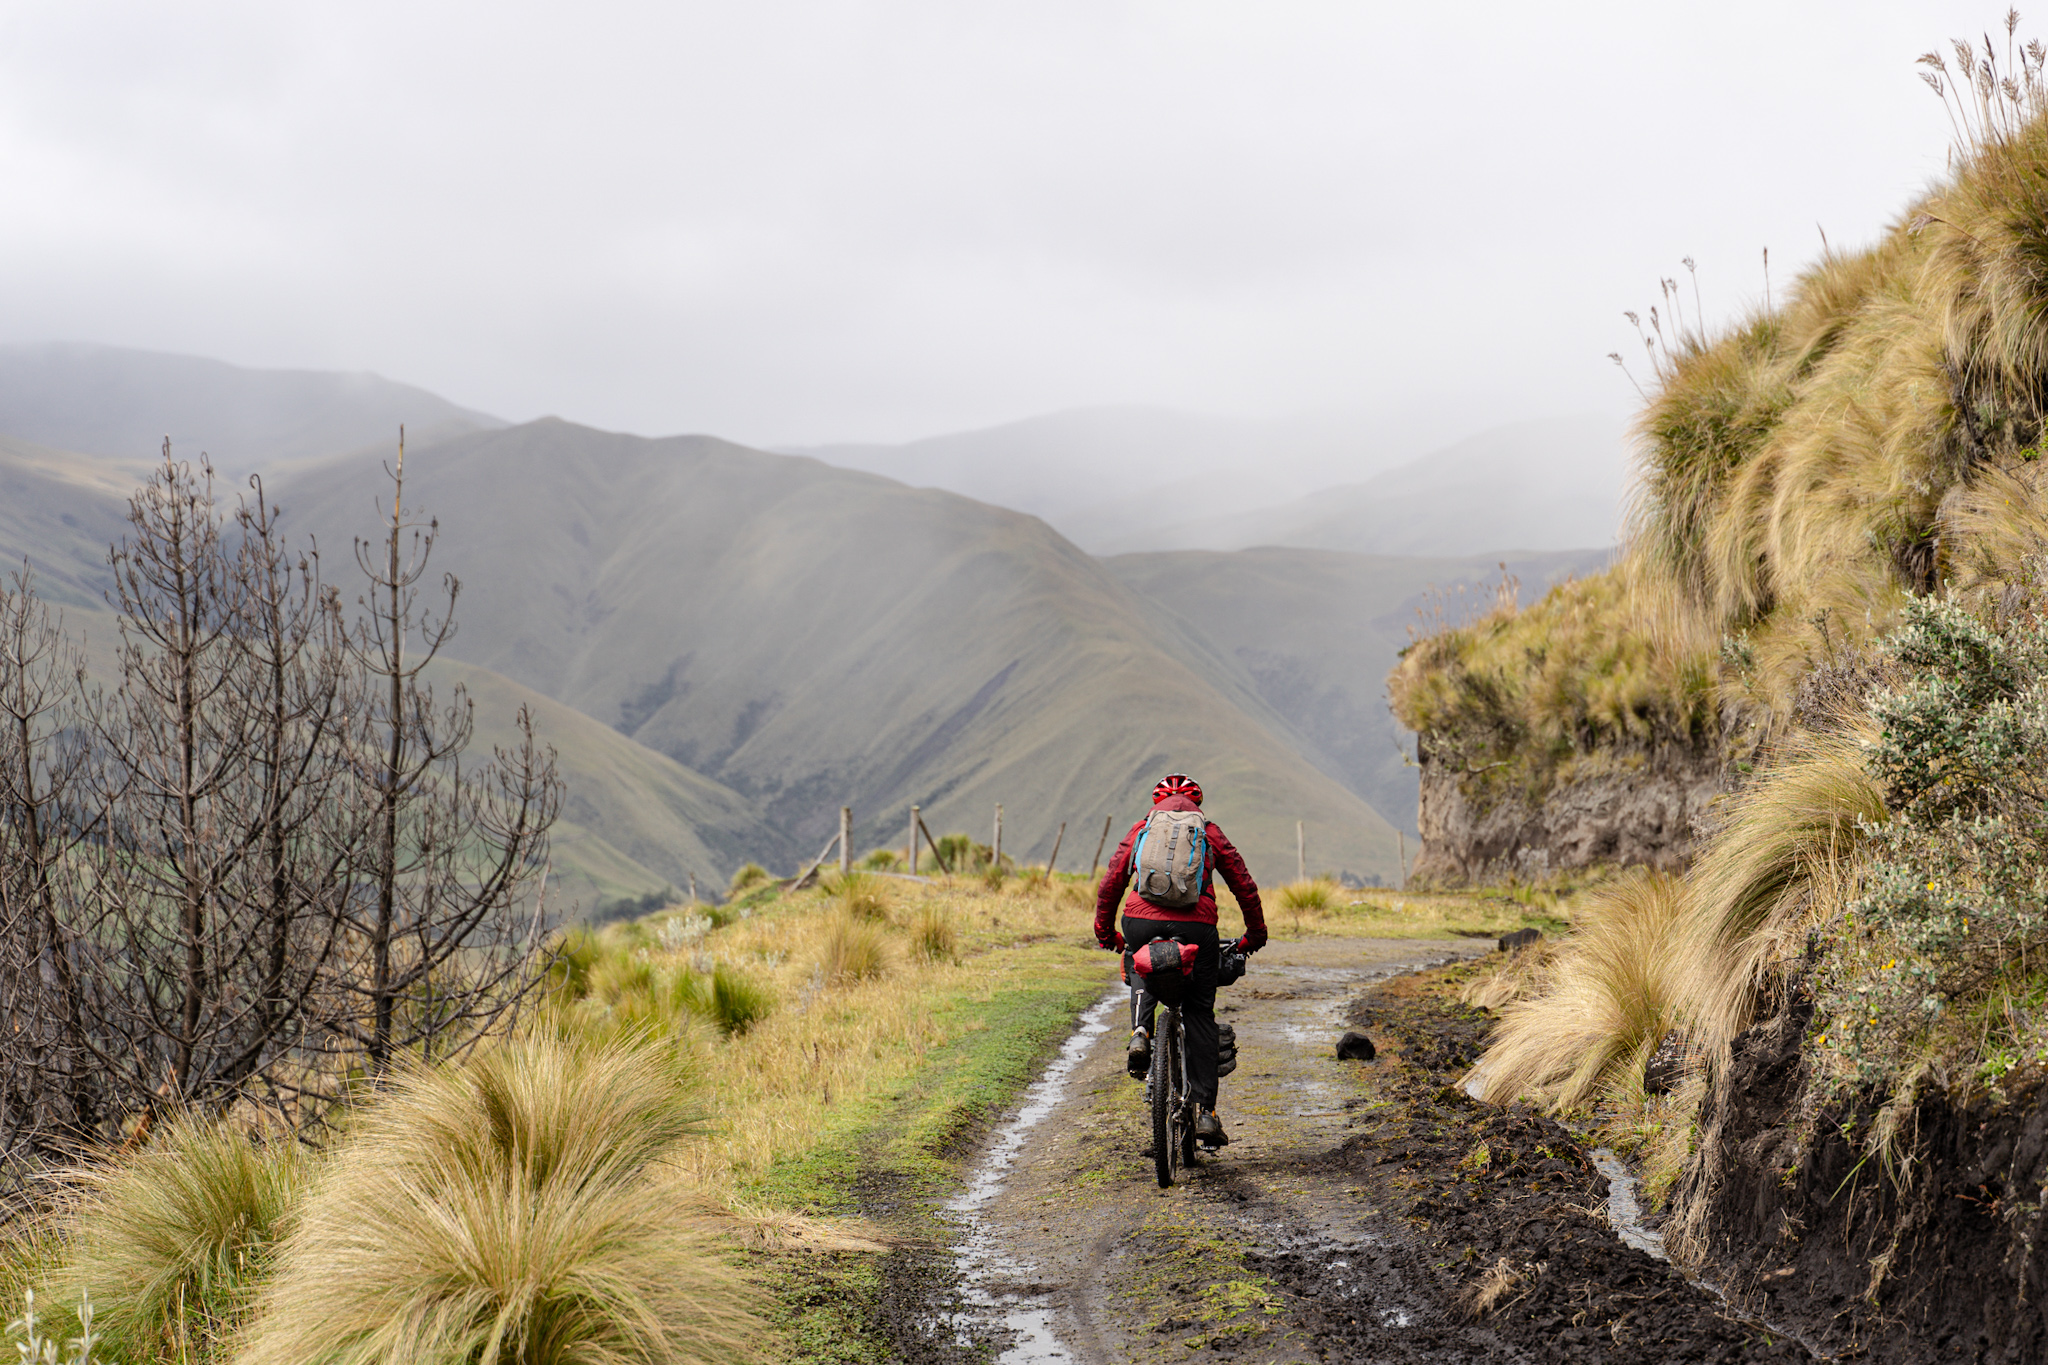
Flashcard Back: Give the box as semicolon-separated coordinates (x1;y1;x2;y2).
801;407;1626;555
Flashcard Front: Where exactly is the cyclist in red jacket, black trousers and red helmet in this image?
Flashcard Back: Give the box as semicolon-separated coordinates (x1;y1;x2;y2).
1096;774;1266;1146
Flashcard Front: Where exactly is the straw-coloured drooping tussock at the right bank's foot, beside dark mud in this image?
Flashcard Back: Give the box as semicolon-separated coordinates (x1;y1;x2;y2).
1483;870;1688;1111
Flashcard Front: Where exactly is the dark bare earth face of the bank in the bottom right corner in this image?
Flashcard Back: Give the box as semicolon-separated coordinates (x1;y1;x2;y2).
1679;984;2048;1365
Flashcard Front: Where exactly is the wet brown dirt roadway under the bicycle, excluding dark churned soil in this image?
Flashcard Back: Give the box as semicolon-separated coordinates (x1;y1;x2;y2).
937;939;1493;1365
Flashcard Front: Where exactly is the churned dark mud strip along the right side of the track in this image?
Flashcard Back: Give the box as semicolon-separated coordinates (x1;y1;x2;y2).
1335;968;1810;1363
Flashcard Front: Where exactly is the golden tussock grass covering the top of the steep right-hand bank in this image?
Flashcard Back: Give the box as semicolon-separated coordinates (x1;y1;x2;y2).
1391;34;2048;794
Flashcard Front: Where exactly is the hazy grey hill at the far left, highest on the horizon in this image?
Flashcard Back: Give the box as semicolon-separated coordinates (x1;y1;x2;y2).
0;342;504;475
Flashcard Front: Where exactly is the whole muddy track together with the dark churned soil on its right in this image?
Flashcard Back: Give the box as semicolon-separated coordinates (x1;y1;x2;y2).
903;939;1806;1363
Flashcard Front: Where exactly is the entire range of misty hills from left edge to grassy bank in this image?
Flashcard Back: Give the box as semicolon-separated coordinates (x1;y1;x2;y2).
0;348;1618;907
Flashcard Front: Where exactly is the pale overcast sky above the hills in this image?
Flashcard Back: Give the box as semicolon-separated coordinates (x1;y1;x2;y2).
0;0;2015;444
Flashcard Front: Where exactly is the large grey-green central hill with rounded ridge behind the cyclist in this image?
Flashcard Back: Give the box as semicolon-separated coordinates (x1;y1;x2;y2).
283;420;1395;878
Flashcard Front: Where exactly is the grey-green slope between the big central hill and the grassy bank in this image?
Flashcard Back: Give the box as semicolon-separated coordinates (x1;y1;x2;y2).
1104;548;1610;834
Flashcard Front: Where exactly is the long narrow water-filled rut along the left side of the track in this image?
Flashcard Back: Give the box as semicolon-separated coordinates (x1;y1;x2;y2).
944;986;1130;1365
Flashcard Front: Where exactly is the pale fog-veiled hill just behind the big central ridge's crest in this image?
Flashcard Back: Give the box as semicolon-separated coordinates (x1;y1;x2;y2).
788;407;1417;553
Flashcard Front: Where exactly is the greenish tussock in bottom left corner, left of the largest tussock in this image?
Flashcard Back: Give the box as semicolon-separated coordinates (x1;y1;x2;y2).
51;1119;311;1361
